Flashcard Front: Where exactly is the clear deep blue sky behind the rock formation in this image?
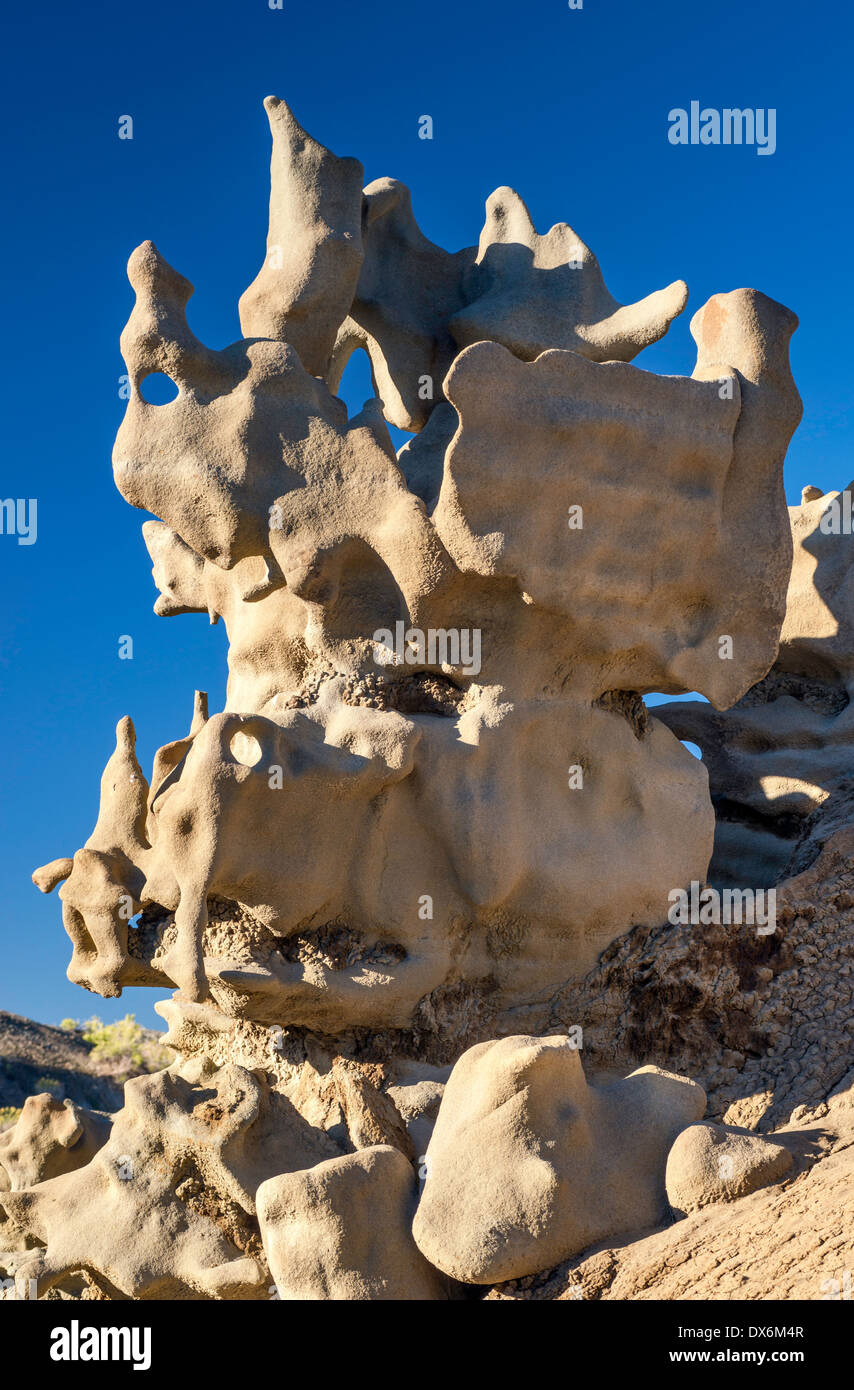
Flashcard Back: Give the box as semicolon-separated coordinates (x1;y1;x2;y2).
0;0;854;1026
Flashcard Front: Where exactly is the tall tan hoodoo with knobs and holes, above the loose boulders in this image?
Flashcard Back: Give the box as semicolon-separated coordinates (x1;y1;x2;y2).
39;99;800;1056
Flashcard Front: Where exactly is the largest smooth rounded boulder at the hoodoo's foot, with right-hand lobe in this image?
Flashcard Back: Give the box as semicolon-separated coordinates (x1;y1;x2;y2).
413;1037;705;1284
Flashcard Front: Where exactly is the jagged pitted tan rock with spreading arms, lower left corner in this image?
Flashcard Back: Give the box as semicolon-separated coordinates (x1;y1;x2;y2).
0;1066;335;1298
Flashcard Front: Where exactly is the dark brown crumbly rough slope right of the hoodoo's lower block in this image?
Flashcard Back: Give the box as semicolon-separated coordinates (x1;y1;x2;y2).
552;824;854;1131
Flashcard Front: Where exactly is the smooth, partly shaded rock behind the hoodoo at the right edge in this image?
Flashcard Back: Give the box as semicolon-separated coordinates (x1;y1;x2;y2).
656;484;854;887
